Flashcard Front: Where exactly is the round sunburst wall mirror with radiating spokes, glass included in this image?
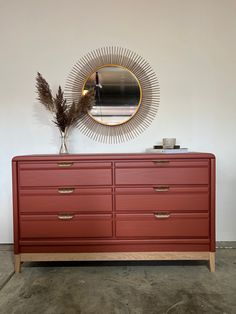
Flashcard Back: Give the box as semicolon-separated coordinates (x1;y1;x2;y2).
65;47;160;143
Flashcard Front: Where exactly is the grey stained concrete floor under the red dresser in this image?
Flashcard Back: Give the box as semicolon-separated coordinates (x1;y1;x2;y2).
0;249;236;314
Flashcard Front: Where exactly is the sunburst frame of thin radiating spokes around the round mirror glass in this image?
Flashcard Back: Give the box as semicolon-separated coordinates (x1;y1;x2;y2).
65;47;160;144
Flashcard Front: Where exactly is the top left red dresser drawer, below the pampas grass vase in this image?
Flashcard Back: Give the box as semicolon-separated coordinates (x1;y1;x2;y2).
19;162;112;187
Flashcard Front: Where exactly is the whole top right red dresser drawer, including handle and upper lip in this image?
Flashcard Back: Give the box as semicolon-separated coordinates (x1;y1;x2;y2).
115;160;209;185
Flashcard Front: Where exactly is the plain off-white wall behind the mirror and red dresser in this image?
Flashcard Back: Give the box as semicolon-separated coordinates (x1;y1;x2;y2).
0;0;236;243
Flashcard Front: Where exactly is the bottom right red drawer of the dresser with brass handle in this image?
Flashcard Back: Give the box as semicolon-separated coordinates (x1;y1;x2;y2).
116;213;209;238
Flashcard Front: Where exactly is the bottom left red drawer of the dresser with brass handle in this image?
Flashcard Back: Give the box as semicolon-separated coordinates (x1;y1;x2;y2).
20;214;112;239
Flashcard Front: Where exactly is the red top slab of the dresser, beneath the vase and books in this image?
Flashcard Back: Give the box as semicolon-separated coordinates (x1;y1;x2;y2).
13;152;215;161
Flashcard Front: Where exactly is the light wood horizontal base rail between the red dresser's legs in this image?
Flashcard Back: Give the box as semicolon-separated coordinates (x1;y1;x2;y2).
21;252;209;262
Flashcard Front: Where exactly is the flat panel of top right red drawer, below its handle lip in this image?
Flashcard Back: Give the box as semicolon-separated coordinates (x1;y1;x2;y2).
115;166;209;185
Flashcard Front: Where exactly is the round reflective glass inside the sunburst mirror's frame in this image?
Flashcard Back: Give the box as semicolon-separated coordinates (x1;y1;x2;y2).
82;65;142;125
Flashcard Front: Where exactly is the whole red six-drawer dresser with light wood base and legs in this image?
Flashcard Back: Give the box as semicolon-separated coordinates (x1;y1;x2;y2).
12;153;215;272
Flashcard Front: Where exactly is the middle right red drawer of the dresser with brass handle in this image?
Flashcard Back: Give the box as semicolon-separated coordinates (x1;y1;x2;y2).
115;186;209;212
